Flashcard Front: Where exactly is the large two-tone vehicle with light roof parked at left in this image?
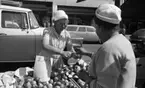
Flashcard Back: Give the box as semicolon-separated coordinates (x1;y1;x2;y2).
0;5;82;67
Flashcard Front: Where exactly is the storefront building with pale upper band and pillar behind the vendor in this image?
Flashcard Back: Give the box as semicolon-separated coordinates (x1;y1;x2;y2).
6;0;114;26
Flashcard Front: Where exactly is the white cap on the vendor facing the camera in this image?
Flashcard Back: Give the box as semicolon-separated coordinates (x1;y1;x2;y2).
52;10;68;21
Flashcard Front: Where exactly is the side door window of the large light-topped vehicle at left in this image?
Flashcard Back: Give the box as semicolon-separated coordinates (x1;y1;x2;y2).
2;11;28;29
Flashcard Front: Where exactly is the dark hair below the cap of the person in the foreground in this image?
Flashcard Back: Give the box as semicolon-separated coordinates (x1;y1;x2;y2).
94;16;118;30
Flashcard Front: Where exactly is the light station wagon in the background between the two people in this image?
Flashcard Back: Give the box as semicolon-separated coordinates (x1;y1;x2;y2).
66;25;99;42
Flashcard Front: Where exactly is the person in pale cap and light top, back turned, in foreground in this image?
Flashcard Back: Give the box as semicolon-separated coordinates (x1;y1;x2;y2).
78;4;136;88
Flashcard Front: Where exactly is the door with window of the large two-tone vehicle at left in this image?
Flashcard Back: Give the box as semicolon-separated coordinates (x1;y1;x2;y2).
0;11;35;62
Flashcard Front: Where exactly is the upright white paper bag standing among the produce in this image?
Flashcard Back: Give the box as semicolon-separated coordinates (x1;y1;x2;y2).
34;55;51;82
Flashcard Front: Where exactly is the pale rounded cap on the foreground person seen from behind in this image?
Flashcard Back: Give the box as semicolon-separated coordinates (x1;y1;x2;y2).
95;4;122;24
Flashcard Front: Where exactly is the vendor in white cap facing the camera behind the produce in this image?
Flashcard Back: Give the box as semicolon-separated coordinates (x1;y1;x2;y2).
40;10;73;75
